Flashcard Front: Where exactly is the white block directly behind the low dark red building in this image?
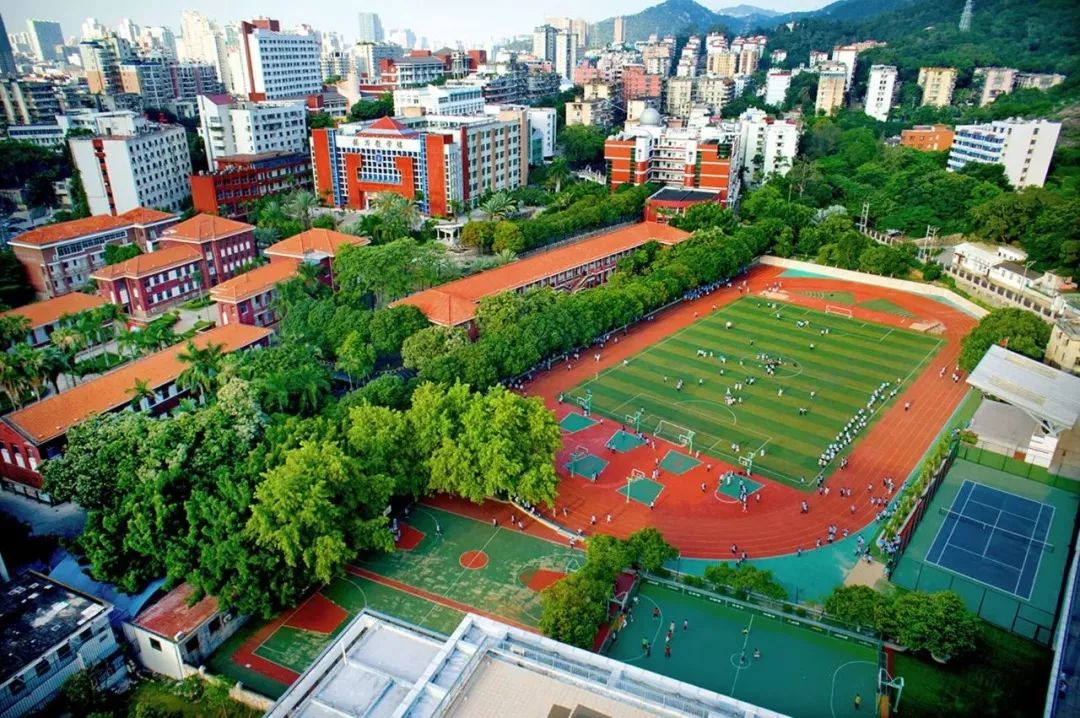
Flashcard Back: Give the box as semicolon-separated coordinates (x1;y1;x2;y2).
199;95;308;167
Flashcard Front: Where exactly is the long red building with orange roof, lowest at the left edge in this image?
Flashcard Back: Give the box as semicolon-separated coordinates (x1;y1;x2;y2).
0;324;270;501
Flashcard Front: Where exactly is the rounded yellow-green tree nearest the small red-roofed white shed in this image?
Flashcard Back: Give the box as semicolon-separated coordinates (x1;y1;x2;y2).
248;441;394;583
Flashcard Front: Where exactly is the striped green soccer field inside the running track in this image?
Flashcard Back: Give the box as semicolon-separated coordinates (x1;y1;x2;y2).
575;297;944;483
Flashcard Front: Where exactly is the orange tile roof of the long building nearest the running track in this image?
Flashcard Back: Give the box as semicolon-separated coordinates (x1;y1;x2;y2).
394;222;690;326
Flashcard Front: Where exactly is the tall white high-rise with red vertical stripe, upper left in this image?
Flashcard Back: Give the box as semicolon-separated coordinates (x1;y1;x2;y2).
240;17;322;99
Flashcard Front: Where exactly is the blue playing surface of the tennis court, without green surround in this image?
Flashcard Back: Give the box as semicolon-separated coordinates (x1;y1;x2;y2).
927;480;1054;599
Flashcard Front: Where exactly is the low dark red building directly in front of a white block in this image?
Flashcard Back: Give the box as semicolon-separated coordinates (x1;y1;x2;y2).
190;152;311;219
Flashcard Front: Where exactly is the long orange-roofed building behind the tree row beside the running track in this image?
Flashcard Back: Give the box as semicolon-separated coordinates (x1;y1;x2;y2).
394;222;690;331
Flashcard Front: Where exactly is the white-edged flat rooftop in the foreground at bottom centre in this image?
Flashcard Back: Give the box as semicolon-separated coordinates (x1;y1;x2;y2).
267;610;778;718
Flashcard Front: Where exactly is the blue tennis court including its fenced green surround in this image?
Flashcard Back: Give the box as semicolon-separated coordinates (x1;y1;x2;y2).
892;455;1080;645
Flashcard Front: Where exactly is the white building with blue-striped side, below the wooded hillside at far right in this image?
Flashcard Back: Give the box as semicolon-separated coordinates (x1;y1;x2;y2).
948;118;1062;189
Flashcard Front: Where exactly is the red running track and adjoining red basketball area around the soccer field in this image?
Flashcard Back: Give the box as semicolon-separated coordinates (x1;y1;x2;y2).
505;267;975;558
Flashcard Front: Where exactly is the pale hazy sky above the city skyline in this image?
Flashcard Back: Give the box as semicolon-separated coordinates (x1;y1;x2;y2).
6;0;829;49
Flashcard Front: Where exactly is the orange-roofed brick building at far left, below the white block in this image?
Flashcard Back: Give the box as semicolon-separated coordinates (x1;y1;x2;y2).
9;207;177;299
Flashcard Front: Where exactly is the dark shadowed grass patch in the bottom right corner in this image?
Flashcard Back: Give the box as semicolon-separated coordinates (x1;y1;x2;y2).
894;624;1051;718
